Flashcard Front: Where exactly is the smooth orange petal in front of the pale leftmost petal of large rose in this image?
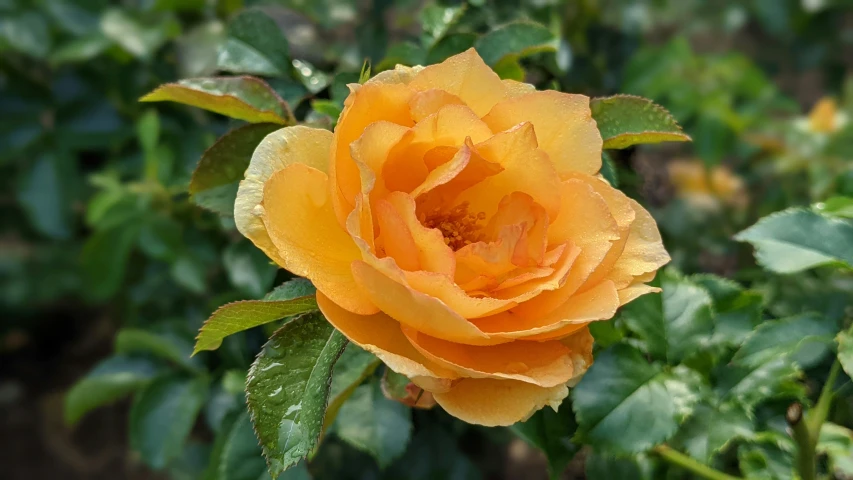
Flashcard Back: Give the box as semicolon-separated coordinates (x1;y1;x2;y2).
263;163;378;314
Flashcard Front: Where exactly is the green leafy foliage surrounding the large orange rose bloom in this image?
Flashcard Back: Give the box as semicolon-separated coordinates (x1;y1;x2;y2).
0;0;853;480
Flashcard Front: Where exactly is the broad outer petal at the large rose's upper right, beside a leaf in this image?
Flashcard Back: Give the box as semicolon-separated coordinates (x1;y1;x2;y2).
483;90;602;175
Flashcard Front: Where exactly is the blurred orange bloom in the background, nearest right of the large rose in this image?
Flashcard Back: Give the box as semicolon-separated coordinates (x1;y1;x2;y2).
667;160;748;210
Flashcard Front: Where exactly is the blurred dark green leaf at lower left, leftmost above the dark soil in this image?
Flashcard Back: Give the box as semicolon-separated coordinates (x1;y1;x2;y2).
65;356;160;425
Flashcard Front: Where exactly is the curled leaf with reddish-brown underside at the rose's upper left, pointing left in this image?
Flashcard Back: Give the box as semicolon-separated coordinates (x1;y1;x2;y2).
139;77;292;125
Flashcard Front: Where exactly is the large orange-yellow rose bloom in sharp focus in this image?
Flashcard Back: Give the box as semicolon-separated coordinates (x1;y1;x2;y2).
235;49;669;425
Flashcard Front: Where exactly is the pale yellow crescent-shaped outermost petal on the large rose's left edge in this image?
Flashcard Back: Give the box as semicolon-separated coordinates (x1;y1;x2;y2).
234;126;332;264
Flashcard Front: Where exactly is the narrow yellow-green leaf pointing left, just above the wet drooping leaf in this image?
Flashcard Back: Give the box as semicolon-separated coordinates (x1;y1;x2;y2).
193;284;317;354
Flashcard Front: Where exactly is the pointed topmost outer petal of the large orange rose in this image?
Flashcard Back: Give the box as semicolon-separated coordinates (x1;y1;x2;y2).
409;48;506;117
